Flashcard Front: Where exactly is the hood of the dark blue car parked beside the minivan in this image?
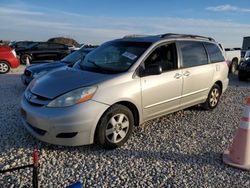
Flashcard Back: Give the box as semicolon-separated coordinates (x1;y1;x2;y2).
27;61;66;73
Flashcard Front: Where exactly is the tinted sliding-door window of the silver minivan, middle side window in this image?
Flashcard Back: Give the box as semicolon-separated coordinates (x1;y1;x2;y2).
179;41;208;68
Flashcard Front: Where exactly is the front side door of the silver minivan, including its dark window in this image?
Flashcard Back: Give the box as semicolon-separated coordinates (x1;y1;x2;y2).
141;43;183;120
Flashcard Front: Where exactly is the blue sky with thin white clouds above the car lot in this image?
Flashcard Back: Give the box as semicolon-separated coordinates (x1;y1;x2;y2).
0;0;250;47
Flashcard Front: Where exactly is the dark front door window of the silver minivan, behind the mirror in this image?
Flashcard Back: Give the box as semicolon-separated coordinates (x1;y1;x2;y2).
144;43;177;72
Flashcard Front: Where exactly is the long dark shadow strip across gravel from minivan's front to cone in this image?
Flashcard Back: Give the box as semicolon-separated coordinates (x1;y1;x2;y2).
39;144;240;172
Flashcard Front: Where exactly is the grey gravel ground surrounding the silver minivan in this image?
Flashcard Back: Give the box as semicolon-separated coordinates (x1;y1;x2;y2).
0;67;250;187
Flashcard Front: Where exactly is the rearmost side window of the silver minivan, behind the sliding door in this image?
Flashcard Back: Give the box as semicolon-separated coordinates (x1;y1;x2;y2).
204;42;225;63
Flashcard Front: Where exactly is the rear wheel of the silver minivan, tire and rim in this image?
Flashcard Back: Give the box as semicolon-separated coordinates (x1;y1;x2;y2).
202;84;221;110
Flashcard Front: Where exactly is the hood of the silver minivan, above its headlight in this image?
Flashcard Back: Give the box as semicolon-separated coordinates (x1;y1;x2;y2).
30;67;112;99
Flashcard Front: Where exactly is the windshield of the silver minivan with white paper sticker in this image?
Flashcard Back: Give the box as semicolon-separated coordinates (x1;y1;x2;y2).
80;41;151;73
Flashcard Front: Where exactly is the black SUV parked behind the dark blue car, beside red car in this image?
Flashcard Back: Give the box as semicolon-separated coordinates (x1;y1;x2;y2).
16;42;71;64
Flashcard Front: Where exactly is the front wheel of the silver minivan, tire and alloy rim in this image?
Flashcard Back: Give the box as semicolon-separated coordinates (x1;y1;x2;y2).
95;104;134;149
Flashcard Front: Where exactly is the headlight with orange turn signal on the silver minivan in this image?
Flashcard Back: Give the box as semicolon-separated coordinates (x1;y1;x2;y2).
47;86;97;107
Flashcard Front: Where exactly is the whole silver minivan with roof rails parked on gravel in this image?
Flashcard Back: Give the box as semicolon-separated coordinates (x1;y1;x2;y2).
21;33;228;149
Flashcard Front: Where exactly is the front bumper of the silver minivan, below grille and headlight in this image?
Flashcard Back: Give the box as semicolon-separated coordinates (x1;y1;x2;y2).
21;97;109;146
